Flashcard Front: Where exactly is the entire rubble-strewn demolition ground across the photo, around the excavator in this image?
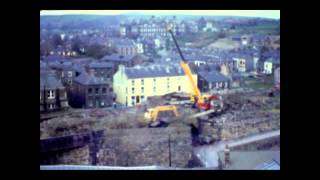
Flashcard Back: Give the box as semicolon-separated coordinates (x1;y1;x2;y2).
40;86;280;167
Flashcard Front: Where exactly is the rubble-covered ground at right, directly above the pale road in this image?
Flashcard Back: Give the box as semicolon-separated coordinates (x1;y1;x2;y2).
214;93;280;139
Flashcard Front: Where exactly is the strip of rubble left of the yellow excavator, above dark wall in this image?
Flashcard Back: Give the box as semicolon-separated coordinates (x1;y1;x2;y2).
40;108;148;139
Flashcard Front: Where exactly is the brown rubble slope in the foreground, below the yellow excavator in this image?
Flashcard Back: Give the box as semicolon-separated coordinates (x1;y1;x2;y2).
97;127;192;167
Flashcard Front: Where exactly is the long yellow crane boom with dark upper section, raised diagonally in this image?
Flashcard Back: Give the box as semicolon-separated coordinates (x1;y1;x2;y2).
168;29;202;101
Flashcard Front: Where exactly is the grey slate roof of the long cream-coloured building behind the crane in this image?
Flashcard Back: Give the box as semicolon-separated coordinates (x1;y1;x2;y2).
125;64;195;79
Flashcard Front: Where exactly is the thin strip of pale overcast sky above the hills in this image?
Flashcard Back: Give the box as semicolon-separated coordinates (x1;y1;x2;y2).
40;10;280;19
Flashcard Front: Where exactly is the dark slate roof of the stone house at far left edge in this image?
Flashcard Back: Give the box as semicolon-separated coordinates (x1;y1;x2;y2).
40;71;63;89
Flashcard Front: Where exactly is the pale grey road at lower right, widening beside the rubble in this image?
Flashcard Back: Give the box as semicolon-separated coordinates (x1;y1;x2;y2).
194;130;280;168
